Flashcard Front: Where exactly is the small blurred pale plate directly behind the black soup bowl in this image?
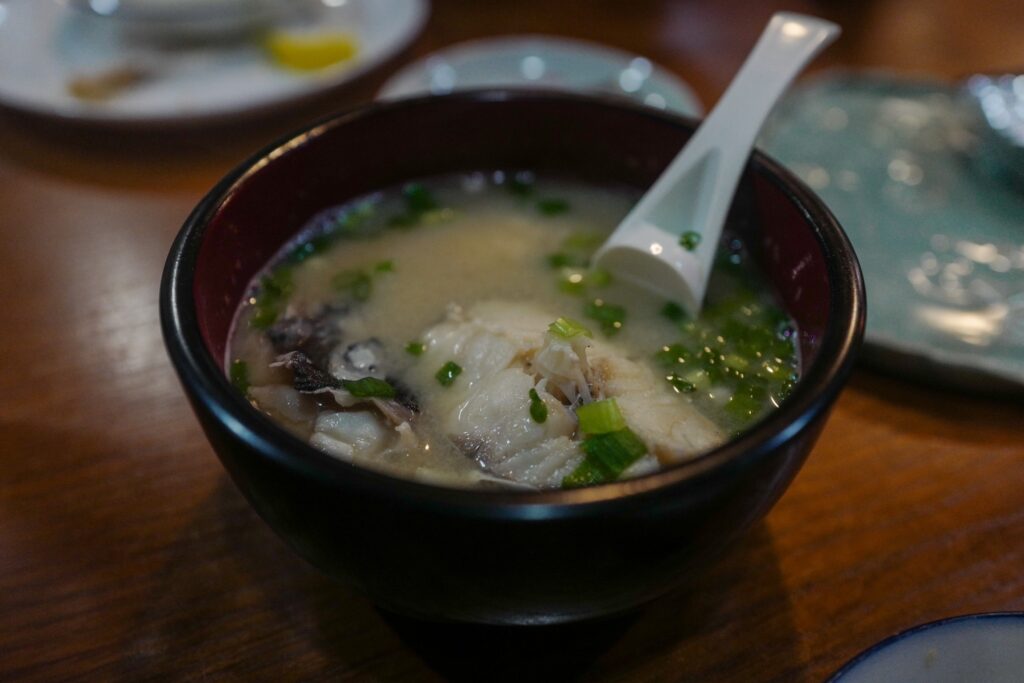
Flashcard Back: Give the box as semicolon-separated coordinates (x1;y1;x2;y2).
378;36;703;116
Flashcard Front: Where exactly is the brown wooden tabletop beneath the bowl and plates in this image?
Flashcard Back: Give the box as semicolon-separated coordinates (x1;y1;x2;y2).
0;0;1024;681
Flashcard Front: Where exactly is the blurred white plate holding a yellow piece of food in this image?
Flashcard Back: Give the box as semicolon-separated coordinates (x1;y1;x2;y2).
0;0;429;124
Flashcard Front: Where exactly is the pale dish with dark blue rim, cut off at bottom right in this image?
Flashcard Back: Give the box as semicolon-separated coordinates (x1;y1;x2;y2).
828;612;1024;683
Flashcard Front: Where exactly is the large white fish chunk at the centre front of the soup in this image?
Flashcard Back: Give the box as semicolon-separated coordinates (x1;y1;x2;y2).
414;301;723;486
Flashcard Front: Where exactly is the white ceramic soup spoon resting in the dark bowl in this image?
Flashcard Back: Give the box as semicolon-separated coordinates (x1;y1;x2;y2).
594;12;840;315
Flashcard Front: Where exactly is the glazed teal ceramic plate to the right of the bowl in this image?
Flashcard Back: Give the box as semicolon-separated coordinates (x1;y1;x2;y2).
760;75;1024;394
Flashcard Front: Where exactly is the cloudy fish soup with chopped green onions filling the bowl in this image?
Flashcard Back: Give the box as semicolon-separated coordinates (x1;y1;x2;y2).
226;171;799;488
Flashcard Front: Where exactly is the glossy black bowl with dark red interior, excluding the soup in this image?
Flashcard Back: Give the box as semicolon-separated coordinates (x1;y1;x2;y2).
161;91;864;624
